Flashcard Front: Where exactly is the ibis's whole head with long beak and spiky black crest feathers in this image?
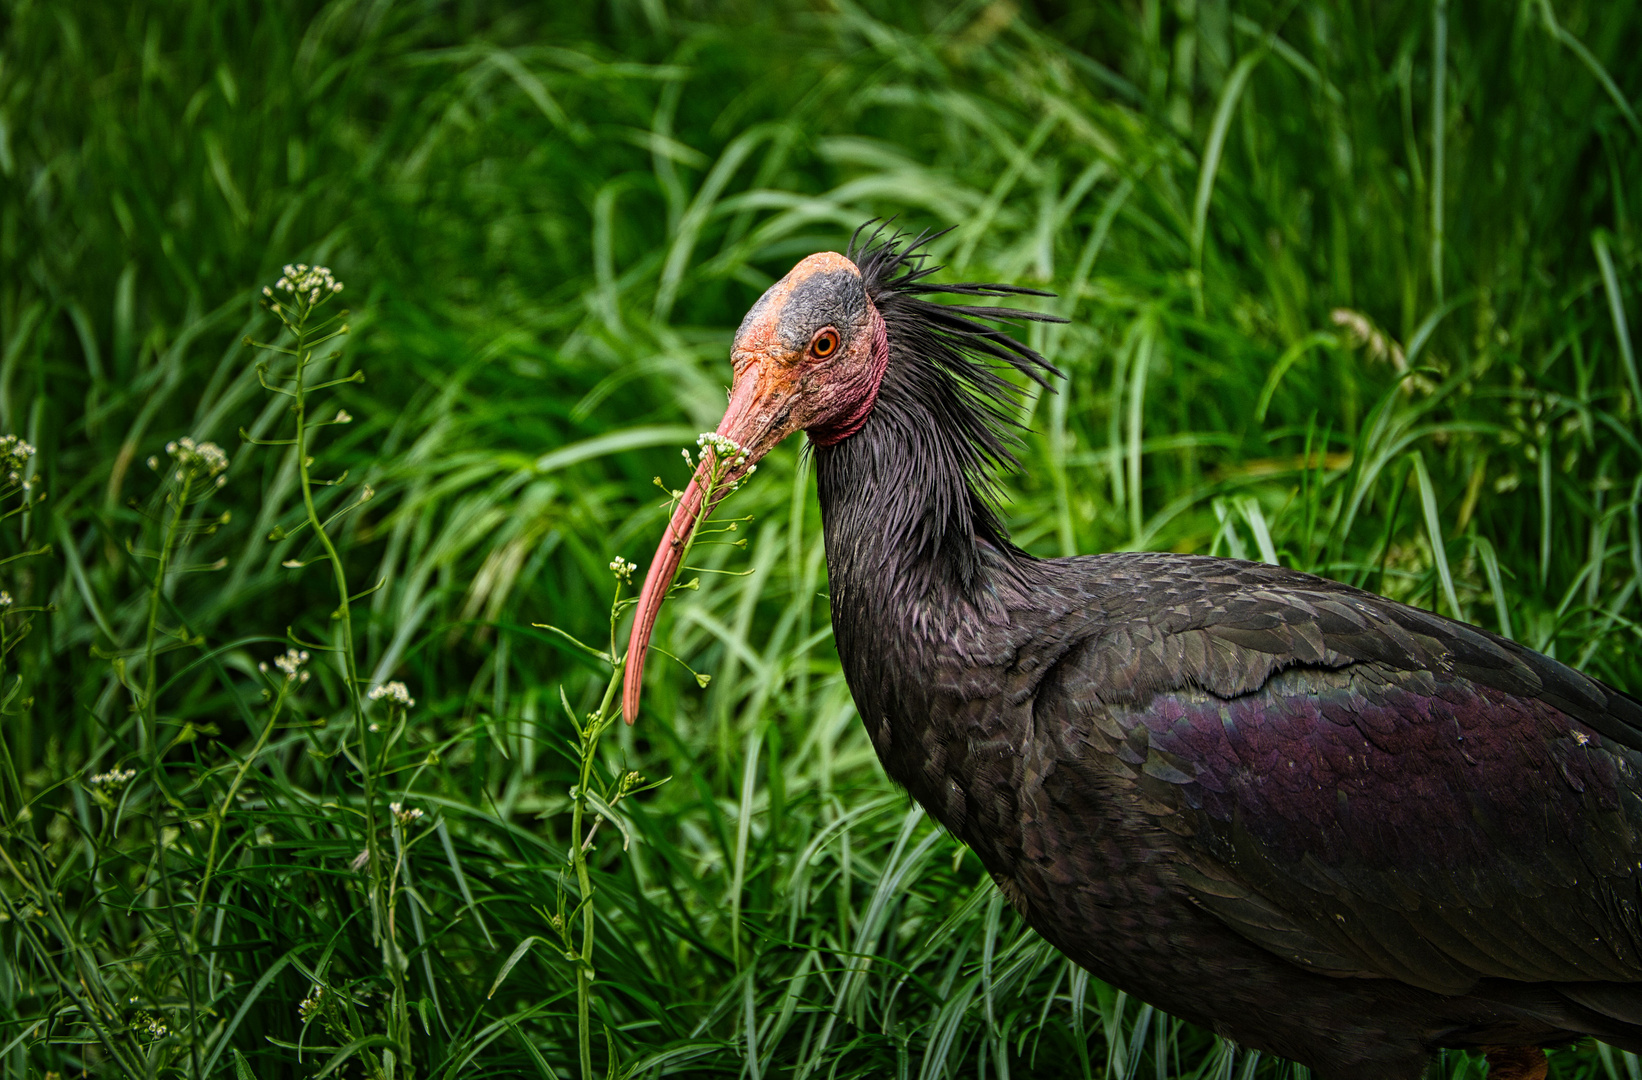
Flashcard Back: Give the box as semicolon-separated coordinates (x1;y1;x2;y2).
622;227;1066;722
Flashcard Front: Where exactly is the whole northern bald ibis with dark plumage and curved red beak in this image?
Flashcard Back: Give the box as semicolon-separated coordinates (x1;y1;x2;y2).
622;229;1642;1080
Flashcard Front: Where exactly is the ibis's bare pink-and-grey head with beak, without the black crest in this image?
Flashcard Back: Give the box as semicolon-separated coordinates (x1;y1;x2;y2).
622;251;890;722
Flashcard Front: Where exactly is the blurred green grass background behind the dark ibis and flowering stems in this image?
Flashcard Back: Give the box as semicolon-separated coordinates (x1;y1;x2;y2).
0;0;1642;1080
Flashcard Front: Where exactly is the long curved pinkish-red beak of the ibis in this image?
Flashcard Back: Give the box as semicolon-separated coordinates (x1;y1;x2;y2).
621;359;798;724
